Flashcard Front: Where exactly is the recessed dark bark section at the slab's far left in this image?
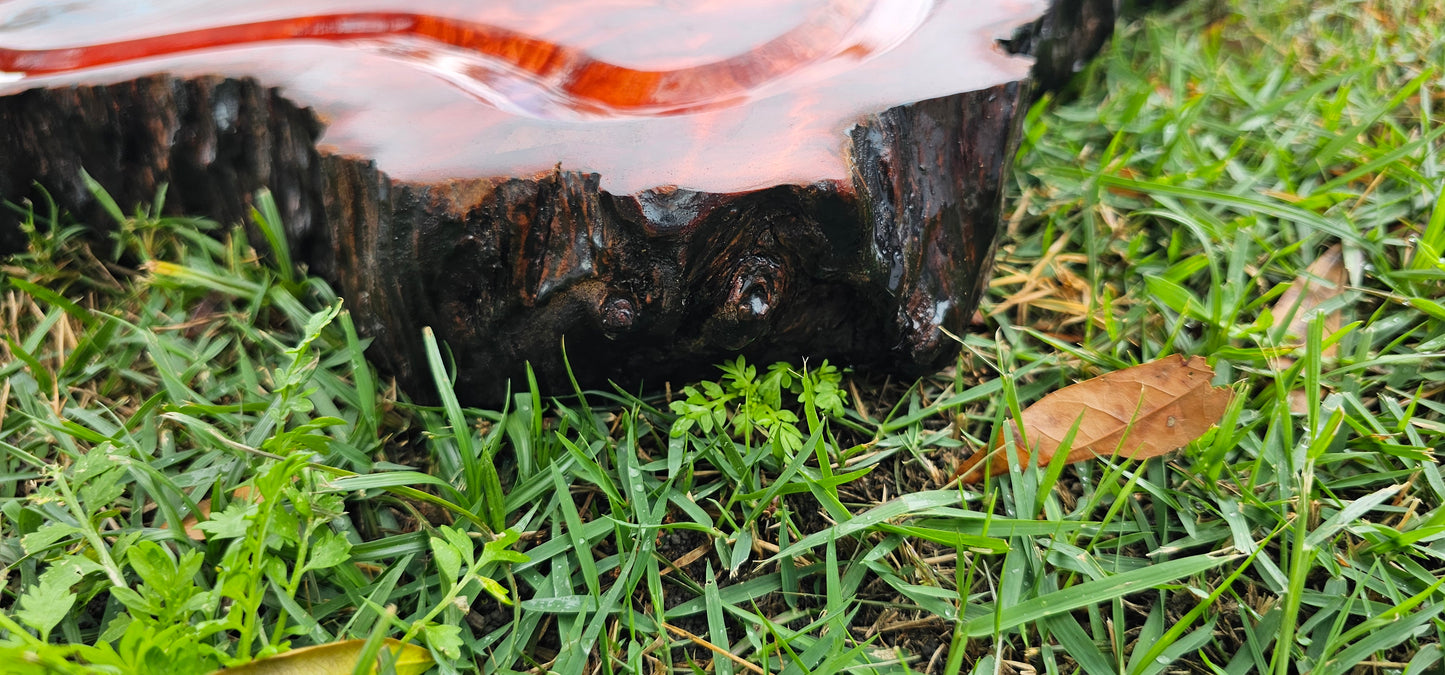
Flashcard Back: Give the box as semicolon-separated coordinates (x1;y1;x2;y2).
0;77;324;251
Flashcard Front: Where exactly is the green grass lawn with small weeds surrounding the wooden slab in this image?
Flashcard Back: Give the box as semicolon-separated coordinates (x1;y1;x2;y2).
0;0;1445;675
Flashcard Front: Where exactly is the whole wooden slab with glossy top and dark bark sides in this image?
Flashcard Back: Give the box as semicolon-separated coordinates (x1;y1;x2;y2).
0;0;1113;403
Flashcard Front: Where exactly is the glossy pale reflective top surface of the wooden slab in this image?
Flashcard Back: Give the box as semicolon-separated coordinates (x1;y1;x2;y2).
0;0;1043;192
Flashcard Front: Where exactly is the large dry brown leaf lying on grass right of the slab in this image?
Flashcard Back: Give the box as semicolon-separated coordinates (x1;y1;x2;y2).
955;354;1234;483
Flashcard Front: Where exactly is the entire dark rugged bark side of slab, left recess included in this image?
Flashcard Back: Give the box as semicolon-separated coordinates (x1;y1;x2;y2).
0;3;1113;403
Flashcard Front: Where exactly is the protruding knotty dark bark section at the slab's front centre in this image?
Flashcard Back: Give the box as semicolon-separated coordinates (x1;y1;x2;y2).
306;85;1020;399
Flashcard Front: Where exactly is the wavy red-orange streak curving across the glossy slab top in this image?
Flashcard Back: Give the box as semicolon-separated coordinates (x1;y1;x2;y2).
0;0;900;116
